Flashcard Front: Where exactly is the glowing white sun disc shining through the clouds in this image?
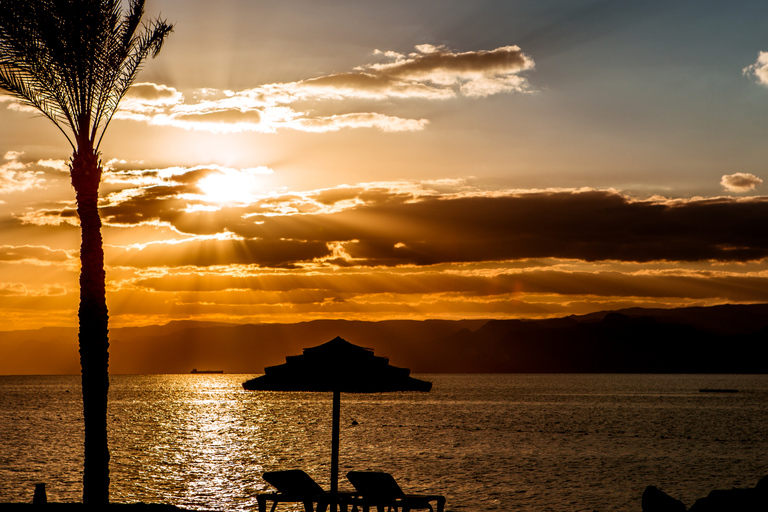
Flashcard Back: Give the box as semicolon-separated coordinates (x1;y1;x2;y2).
197;167;271;204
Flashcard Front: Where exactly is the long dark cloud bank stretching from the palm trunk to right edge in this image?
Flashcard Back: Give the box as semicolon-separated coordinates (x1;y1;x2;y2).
40;180;768;267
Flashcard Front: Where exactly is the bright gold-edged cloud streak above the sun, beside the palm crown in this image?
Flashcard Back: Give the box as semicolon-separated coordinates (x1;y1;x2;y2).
115;44;534;133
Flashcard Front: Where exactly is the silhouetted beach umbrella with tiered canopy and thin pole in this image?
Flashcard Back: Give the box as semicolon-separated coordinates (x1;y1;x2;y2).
243;337;432;504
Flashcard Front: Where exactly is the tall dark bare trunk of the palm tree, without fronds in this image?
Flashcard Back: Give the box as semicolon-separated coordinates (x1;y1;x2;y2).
71;150;109;505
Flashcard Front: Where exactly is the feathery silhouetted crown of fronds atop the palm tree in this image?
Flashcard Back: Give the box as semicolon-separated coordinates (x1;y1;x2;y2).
0;0;173;151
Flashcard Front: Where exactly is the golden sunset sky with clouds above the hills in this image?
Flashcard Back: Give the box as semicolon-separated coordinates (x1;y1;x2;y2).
0;0;768;330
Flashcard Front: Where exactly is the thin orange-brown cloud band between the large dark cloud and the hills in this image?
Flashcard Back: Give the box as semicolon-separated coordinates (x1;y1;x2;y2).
135;268;768;302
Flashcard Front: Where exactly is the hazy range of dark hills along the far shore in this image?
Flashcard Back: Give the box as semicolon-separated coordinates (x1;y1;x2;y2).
0;304;768;375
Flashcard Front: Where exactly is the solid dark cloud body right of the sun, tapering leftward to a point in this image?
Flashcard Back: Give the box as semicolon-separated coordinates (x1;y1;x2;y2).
226;191;768;265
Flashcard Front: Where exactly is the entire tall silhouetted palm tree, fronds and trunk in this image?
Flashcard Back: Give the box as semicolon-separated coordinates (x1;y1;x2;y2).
0;0;173;504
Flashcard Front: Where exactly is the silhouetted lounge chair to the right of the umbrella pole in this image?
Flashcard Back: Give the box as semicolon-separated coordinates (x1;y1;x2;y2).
347;471;445;512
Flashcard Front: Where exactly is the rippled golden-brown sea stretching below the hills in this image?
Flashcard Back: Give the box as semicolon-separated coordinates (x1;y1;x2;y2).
0;374;768;512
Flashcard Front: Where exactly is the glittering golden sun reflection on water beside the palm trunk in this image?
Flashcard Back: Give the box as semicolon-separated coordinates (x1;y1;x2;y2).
110;375;276;509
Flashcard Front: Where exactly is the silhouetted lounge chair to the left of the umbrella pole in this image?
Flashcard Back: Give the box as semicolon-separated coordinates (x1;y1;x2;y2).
256;469;352;512
